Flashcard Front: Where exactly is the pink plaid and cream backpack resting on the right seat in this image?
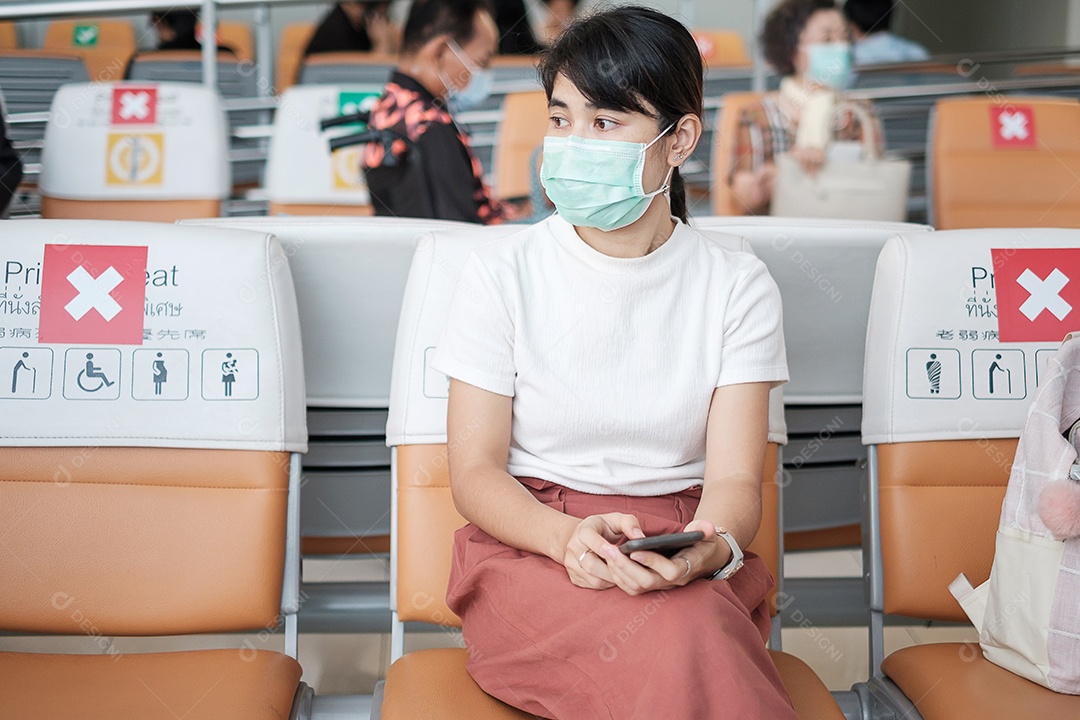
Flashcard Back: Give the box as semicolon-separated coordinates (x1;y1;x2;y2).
949;332;1080;695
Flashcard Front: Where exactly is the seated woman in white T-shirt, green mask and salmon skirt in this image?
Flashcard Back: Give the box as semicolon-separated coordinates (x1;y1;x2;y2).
432;6;796;720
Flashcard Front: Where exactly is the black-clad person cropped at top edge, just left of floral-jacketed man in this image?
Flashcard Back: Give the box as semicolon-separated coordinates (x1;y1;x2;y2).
303;0;400;55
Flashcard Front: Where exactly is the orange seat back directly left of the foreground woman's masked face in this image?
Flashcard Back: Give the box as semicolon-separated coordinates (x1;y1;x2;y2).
495;90;548;198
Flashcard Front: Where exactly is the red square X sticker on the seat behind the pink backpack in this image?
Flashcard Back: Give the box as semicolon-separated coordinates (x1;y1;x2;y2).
990;247;1080;342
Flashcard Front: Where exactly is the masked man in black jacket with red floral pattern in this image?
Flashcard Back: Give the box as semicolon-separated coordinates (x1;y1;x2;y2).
363;0;516;223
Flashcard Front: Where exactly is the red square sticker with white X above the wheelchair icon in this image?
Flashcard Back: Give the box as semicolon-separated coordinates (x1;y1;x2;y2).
38;245;146;345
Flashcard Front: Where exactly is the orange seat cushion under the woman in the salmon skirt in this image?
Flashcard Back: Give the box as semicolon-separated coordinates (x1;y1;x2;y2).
381;648;843;720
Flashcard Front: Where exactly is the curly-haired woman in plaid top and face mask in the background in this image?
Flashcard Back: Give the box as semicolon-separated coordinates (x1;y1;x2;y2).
729;0;881;215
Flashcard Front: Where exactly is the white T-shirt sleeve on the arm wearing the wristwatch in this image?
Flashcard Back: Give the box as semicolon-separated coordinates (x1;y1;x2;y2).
716;258;787;388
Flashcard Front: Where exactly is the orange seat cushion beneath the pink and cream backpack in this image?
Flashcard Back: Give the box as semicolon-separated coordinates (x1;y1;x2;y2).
881;642;1080;720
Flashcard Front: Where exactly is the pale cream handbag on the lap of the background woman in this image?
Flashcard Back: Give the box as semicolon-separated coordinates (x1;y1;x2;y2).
769;103;912;222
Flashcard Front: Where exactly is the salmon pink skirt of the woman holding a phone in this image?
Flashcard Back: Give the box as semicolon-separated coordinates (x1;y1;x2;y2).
447;478;796;720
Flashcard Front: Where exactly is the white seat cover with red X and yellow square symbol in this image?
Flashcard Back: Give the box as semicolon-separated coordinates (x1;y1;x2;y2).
40;82;230;200
